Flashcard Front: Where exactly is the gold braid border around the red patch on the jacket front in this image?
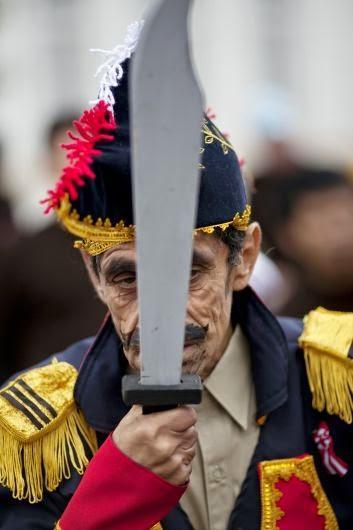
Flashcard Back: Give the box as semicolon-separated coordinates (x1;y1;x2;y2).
260;455;339;530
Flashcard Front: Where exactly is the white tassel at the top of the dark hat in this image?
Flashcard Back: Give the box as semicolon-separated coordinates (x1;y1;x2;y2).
90;20;144;110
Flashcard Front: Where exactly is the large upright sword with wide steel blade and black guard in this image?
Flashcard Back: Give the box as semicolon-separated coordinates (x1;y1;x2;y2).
123;0;203;406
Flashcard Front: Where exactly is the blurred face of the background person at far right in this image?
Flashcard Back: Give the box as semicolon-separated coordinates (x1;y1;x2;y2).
278;186;353;294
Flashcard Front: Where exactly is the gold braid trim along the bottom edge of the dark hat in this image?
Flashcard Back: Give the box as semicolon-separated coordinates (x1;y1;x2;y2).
56;196;251;256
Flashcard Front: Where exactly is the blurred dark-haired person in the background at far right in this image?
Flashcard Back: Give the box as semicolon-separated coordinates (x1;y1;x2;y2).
253;141;353;318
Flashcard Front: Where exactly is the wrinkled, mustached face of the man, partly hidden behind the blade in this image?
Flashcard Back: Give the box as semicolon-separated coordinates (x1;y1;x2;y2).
95;234;241;378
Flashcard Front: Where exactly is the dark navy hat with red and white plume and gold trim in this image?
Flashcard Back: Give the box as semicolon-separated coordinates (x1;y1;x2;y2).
44;23;250;255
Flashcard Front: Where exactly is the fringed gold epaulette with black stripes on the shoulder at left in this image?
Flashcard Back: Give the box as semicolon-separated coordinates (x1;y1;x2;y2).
0;360;97;503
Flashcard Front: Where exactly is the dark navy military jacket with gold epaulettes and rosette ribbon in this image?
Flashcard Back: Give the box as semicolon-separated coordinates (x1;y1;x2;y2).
0;288;353;530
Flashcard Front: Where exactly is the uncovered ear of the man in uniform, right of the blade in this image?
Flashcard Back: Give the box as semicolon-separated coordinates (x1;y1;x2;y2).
233;223;262;291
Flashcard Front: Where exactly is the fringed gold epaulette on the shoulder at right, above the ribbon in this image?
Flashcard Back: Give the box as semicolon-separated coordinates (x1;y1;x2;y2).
299;307;353;423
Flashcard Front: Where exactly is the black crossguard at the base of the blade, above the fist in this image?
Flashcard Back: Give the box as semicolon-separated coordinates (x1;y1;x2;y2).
122;374;202;406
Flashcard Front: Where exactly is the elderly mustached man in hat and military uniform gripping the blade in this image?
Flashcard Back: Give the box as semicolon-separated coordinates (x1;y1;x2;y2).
0;23;353;530
